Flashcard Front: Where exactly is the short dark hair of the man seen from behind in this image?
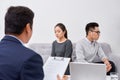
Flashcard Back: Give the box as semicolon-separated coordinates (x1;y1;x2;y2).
5;6;34;35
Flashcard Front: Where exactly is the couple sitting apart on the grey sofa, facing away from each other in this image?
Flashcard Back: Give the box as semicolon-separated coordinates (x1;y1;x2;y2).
51;22;115;75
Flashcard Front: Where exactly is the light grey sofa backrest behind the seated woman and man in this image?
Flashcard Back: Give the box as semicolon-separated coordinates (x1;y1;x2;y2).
29;43;112;63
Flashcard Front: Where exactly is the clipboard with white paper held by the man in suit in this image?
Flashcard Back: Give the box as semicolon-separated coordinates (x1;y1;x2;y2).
43;57;70;80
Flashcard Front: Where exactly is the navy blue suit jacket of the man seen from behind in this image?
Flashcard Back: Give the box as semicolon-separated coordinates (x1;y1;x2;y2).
0;36;44;80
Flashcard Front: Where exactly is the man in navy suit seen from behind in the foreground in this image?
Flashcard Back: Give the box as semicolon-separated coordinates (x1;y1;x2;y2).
0;6;44;80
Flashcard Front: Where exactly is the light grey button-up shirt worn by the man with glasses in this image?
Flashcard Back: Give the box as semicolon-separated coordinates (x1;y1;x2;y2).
76;38;107;62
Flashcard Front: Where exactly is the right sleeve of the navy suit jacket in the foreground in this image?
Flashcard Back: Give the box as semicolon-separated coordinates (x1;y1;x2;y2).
20;54;44;80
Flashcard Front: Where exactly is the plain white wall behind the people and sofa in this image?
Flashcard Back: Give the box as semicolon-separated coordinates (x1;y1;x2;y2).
0;0;120;53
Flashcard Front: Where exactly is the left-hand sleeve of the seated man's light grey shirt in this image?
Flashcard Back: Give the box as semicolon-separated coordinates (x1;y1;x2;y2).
75;42;87;63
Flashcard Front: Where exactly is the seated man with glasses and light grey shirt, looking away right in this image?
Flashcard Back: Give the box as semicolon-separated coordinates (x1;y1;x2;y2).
76;22;115;74
